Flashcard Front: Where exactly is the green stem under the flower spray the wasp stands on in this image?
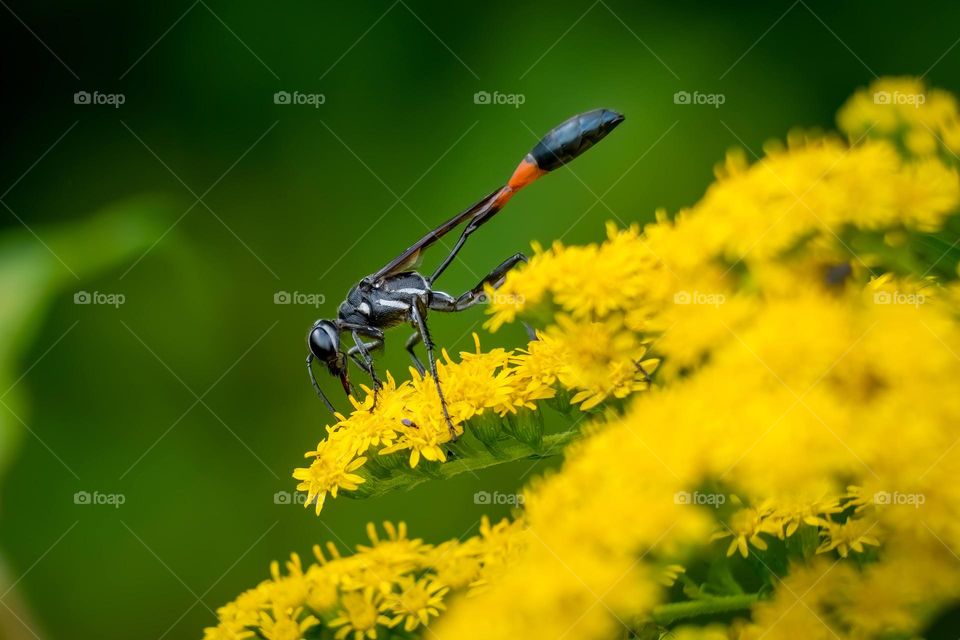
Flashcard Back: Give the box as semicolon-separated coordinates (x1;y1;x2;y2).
350;429;580;498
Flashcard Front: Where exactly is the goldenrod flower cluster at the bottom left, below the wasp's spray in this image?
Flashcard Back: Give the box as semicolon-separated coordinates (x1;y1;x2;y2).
198;518;525;640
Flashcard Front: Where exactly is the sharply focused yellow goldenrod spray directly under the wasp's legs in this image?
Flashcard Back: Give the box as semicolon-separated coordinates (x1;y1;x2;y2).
293;330;658;514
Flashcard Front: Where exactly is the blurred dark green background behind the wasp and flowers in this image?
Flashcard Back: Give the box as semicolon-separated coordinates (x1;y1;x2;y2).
0;0;960;638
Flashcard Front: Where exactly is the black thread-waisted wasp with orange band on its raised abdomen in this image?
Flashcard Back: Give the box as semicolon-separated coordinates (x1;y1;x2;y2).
307;109;624;438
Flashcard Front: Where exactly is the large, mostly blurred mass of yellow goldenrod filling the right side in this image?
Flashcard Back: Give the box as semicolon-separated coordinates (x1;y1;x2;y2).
436;77;960;640
